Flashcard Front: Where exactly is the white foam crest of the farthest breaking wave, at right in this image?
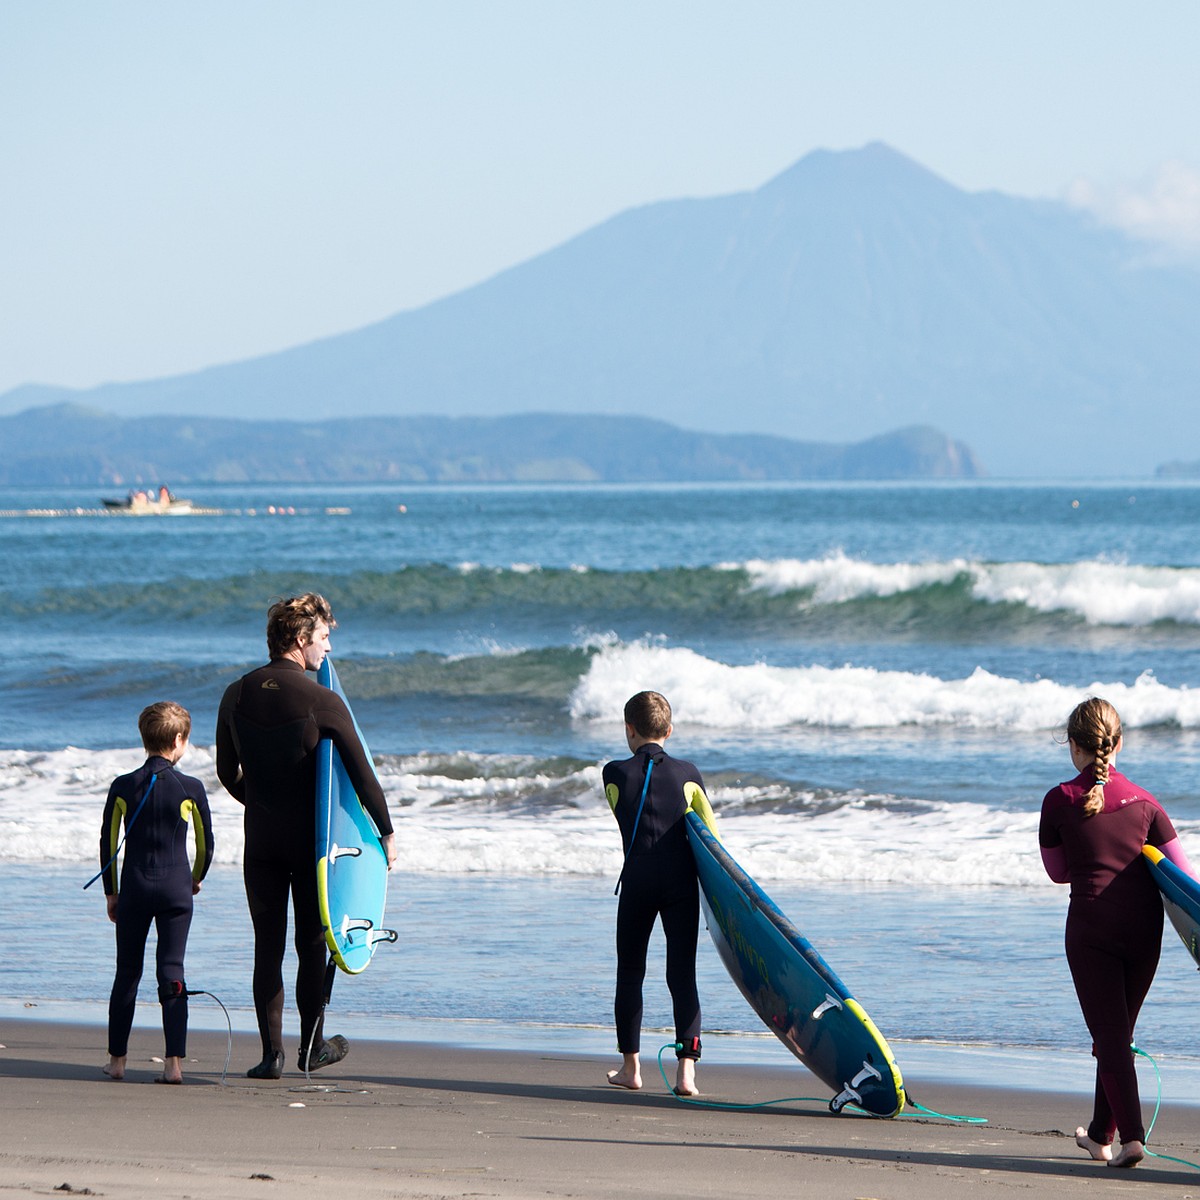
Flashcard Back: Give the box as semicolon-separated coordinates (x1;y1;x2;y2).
721;553;1200;626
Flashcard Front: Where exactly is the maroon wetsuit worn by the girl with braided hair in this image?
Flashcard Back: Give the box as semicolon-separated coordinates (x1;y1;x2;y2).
1038;767;1175;1145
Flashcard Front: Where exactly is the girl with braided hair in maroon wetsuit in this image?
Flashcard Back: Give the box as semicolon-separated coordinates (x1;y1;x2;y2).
1038;696;1193;1166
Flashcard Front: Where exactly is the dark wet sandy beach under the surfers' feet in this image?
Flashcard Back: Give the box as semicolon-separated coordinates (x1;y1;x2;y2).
0;1020;1200;1200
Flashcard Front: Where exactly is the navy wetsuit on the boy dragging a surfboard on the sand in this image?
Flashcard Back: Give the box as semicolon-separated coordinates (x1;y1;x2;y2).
604;742;704;1058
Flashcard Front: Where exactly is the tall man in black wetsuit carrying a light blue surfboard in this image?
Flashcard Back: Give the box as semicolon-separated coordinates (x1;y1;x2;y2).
216;593;396;1079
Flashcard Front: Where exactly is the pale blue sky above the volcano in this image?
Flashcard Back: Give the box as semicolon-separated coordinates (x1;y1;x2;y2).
0;0;1200;394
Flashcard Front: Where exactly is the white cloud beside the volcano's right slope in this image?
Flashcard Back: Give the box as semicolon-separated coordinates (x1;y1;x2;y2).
1067;162;1200;254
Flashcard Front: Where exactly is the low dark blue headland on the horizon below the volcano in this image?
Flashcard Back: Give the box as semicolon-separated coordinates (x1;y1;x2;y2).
0;404;983;488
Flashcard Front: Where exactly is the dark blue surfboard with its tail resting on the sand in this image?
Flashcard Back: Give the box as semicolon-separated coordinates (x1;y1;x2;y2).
684;784;906;1117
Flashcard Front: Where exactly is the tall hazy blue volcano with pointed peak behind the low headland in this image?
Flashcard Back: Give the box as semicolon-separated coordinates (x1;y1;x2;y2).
0;144;1200;476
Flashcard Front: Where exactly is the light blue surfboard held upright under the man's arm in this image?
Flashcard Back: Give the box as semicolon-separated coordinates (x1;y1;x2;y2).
317;655;396;974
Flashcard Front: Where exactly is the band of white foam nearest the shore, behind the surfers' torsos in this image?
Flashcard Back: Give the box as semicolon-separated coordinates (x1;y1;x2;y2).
0;748;1200;888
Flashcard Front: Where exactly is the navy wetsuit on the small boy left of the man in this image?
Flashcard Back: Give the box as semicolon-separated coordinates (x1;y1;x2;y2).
100;755;212;1058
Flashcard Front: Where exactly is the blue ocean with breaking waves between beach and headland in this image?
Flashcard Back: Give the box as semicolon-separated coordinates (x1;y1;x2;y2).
0;481;1200;1094
